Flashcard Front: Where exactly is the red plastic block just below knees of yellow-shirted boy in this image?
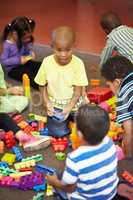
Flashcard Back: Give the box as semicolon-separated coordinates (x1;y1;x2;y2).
51;137;68;152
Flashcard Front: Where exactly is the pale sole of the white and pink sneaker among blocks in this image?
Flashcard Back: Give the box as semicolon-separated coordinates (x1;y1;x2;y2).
23;138;50;151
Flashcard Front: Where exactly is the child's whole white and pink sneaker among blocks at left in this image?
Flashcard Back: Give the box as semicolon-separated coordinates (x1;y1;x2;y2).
23;136;50;151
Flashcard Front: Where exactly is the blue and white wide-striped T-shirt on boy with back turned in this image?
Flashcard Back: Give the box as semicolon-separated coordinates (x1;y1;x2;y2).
62;136;118;200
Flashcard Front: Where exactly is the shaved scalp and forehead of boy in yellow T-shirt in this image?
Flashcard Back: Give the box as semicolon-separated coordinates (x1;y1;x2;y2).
52;26;75;43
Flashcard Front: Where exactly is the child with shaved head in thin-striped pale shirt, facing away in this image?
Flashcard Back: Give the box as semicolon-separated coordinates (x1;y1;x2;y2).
100;12;133;66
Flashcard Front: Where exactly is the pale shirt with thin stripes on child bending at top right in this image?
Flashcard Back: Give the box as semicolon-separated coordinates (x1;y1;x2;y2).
100;25;133;66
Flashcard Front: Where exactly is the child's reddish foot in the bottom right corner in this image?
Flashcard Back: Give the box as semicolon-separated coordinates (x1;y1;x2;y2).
118;183;133;200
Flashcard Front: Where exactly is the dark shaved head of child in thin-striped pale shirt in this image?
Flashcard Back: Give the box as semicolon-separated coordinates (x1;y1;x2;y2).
100;12;121;32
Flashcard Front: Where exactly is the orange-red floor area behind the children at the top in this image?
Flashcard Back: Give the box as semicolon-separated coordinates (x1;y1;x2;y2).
0;0;133;54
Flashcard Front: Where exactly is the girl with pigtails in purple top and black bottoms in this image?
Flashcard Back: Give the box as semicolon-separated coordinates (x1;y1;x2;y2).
0;16;41;89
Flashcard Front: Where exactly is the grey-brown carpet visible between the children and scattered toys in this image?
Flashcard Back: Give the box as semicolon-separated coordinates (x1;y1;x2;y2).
0;47;133;200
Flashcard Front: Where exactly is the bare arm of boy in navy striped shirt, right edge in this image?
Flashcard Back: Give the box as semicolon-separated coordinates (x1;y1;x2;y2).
123;119;133;157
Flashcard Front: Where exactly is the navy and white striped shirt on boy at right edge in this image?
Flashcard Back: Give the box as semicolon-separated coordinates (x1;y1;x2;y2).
116;72;133;123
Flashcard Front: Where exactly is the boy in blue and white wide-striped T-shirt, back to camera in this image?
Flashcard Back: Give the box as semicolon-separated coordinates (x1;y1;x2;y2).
47;104;118;200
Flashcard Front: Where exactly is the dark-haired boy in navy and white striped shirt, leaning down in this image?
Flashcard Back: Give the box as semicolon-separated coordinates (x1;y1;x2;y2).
101;56;133;158
